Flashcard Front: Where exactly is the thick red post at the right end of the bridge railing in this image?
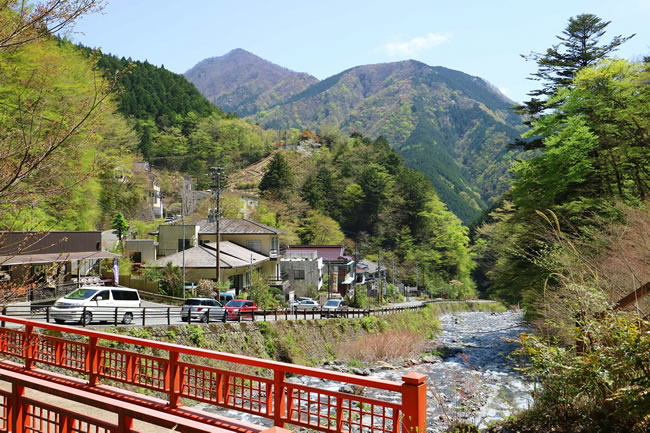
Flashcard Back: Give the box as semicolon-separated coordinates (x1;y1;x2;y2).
401;371;427;433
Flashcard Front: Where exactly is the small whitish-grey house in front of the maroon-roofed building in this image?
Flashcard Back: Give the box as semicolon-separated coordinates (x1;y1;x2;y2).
280;249;324;296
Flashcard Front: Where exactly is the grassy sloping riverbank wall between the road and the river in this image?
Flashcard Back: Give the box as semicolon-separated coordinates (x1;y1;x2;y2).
104;301;505;367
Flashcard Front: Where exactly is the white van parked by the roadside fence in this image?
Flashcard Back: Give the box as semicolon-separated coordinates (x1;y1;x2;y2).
50;286;142;325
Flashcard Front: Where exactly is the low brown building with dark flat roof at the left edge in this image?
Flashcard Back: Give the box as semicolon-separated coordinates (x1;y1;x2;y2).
0;231;120;301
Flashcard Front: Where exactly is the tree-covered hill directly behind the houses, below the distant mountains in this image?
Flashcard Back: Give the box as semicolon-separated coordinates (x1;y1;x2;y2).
254;131;475;297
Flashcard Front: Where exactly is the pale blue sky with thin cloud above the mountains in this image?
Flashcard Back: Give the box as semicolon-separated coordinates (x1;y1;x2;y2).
71;0;650;101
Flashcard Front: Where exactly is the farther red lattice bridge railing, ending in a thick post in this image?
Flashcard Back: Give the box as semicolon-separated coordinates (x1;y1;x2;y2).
0;316;426;433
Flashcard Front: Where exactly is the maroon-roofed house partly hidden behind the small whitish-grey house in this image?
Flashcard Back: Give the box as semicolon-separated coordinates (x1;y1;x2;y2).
284;245;355;296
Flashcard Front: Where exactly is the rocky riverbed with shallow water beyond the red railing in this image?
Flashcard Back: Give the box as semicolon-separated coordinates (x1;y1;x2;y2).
203;311;532;432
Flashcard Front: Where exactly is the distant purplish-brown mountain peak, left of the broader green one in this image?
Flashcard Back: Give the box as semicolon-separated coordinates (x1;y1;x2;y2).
185;48;318;116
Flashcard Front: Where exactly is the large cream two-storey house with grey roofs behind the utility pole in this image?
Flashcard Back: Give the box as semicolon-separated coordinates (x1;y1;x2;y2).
152;218;288;293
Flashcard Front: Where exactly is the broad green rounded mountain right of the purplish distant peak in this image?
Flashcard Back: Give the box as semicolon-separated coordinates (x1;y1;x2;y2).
187;50;522;223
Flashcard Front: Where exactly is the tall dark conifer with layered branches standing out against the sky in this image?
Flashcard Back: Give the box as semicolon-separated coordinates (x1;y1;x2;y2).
514;14;635;150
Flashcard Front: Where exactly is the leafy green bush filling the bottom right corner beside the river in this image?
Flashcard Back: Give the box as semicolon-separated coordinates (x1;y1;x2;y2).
519;313;650;433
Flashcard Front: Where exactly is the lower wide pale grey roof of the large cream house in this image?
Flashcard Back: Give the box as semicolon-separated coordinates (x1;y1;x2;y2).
151;241;269;268
